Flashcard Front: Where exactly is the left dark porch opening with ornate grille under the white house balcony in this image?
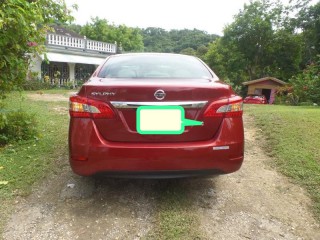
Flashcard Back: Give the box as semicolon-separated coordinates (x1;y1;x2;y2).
41;62;70;85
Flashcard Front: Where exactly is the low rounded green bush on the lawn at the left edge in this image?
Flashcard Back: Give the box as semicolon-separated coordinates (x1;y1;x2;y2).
0;111;38;145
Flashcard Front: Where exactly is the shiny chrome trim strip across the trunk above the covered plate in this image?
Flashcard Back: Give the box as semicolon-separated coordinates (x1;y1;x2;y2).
110;101;208;108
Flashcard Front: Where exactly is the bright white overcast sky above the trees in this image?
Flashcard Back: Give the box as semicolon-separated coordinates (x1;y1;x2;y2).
66;0;250;35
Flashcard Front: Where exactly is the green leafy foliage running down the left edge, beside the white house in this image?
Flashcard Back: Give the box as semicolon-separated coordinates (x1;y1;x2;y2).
0;0;71;145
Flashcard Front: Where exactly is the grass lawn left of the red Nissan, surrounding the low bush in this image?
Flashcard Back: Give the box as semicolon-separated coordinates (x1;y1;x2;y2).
0;90;69;232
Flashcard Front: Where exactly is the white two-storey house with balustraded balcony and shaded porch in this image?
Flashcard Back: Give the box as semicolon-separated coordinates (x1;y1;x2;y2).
30;26;117;85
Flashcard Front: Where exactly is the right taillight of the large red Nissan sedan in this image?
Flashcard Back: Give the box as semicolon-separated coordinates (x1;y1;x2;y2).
204;96;243;118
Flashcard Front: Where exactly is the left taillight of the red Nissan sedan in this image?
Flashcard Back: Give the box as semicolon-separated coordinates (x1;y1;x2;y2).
69;95;115;118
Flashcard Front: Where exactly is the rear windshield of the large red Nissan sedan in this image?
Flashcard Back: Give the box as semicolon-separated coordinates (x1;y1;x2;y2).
98;54;213;79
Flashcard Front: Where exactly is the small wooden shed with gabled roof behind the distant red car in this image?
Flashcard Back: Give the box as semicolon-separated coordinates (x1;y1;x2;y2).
242;77;286;104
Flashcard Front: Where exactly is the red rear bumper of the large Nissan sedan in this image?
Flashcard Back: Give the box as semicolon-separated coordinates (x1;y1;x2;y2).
69;118;244;178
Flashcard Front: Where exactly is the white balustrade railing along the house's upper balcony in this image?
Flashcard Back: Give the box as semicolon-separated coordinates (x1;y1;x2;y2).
47;33;117;53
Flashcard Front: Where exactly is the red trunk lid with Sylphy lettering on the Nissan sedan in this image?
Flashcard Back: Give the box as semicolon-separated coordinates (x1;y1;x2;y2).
79;78;232;143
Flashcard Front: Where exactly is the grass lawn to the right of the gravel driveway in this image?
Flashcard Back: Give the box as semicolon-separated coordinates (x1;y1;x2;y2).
244;105;320;220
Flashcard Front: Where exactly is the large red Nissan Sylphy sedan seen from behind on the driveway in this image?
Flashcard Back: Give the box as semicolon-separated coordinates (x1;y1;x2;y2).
69;53;244;178
